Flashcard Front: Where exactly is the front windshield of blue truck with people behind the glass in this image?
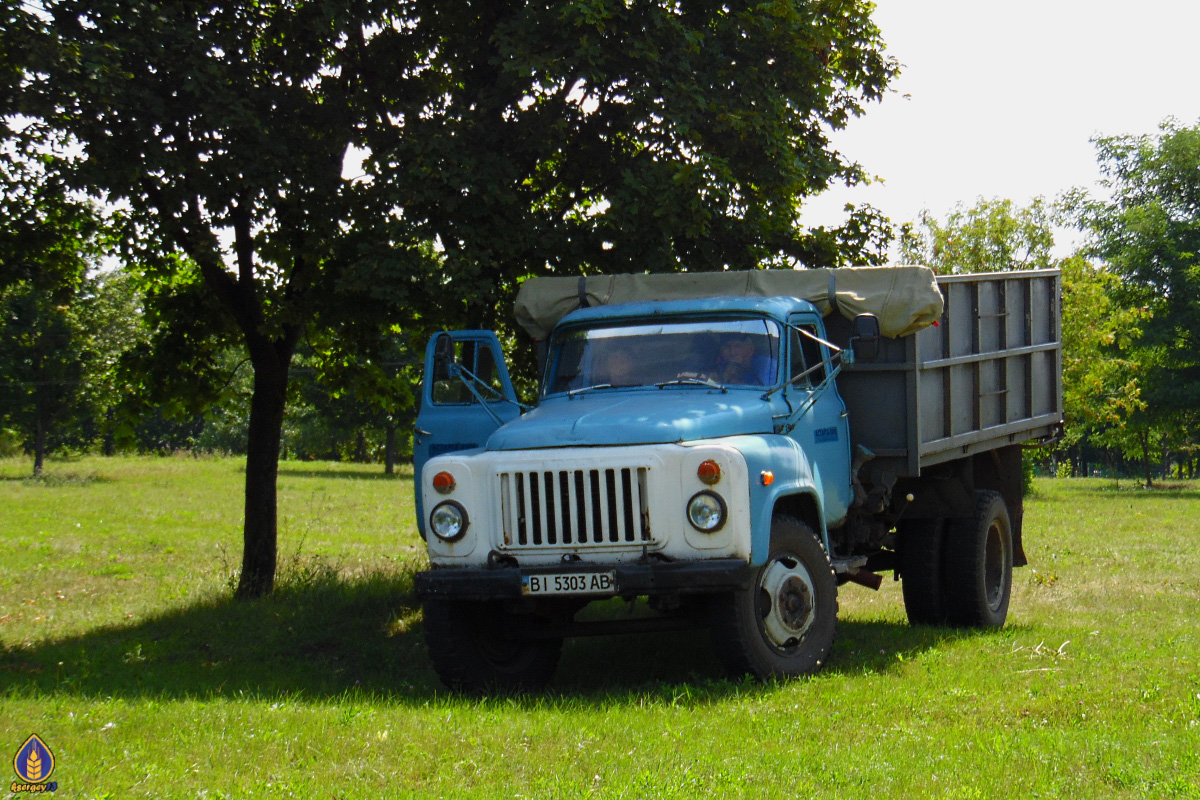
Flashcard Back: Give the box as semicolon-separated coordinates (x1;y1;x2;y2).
546;319;779;393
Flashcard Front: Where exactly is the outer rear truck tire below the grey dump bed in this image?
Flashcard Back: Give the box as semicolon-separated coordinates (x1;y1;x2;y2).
944;492;1013;627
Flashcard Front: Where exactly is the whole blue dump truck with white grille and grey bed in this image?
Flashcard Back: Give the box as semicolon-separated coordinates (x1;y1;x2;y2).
414;266;1062;692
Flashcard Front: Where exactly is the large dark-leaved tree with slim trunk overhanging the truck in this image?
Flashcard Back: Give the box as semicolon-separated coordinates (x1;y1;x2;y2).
6;0;896;596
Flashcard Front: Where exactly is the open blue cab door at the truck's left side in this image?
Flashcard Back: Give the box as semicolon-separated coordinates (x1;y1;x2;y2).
413;331;521;536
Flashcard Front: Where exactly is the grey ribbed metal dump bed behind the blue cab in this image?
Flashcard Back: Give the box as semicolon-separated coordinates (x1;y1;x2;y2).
826;270;1062;477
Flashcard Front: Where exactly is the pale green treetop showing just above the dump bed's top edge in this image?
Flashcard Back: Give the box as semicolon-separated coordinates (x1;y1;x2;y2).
901;197;1054;275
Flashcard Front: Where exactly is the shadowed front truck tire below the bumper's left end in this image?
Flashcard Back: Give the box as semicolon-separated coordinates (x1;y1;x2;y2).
424;600;563;693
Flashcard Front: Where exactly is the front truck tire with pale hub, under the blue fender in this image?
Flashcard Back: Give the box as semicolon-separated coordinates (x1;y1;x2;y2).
710;516;838;679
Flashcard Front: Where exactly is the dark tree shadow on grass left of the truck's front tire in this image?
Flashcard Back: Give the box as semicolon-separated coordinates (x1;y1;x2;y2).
0;571;436;698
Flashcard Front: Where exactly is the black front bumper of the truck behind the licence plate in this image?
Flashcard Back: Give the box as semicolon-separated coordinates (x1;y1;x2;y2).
414;559;754;600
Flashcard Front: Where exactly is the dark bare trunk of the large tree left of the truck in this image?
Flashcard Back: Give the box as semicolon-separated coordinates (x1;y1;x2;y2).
236;341;292;600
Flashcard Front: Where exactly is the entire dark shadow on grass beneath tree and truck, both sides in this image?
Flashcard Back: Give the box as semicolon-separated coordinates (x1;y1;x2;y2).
0;571;978;705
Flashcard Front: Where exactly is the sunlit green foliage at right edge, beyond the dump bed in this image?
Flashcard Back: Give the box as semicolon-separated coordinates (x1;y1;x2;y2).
1064;120;1200;485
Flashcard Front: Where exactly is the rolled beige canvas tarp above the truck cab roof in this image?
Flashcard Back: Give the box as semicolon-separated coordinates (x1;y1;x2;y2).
514;266;942;341
